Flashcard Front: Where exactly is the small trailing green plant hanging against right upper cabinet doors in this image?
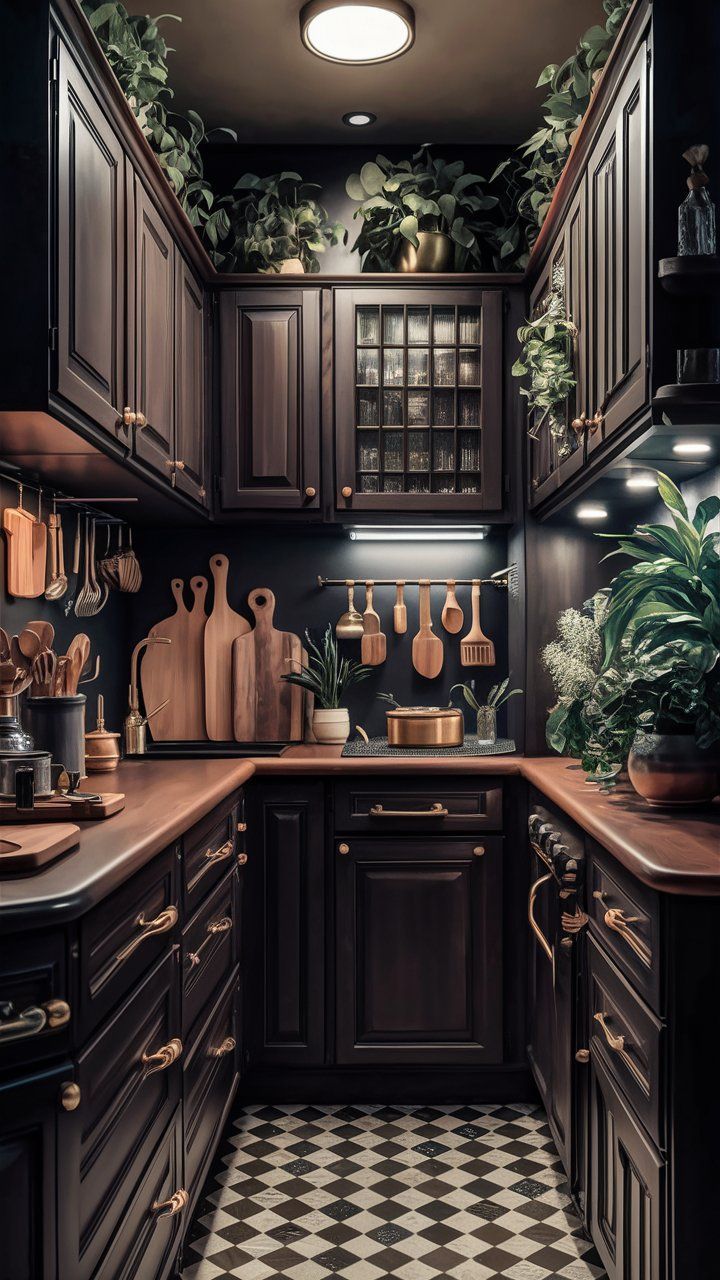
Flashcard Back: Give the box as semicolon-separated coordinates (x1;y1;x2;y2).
512;265;578;458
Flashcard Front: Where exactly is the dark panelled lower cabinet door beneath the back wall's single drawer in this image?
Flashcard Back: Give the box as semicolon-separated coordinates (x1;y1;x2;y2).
334;835;502;1065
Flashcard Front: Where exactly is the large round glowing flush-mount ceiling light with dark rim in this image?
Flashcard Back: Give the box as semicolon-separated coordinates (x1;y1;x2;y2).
300;0;415;63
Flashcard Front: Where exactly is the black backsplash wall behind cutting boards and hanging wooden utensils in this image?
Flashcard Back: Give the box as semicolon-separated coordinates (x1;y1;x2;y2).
129;527;509;733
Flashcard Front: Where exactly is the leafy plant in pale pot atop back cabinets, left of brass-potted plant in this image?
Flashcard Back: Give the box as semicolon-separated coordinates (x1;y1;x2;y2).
215;172;347;273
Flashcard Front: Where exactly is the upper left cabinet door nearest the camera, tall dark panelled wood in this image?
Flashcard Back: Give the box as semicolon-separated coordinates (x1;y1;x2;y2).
58;44;126;435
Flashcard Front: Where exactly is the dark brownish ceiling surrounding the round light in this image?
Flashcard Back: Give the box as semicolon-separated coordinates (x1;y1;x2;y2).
128;0;603;146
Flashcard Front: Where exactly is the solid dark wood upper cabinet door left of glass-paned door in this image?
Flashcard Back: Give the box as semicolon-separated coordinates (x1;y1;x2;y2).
220;285;320;511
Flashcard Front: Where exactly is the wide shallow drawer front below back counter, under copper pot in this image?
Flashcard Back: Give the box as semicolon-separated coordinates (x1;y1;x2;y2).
334;777;502;836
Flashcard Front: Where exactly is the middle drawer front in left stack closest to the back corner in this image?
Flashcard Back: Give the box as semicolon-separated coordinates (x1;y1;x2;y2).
182;870;240;1038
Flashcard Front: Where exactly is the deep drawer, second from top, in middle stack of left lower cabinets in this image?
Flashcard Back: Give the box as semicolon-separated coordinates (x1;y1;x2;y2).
60;948;182;1280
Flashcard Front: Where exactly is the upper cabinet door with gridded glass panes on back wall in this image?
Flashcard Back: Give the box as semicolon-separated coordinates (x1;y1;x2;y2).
334;288;502;511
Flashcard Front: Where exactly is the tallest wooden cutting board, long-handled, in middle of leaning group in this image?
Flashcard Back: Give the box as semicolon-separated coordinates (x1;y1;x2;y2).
204;556;251;742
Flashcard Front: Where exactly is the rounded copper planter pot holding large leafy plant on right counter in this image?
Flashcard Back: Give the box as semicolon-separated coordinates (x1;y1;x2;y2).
628;733;720;806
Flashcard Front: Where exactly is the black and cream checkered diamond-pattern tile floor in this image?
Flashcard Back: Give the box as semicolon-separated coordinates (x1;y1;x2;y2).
182;1105;605;1280
